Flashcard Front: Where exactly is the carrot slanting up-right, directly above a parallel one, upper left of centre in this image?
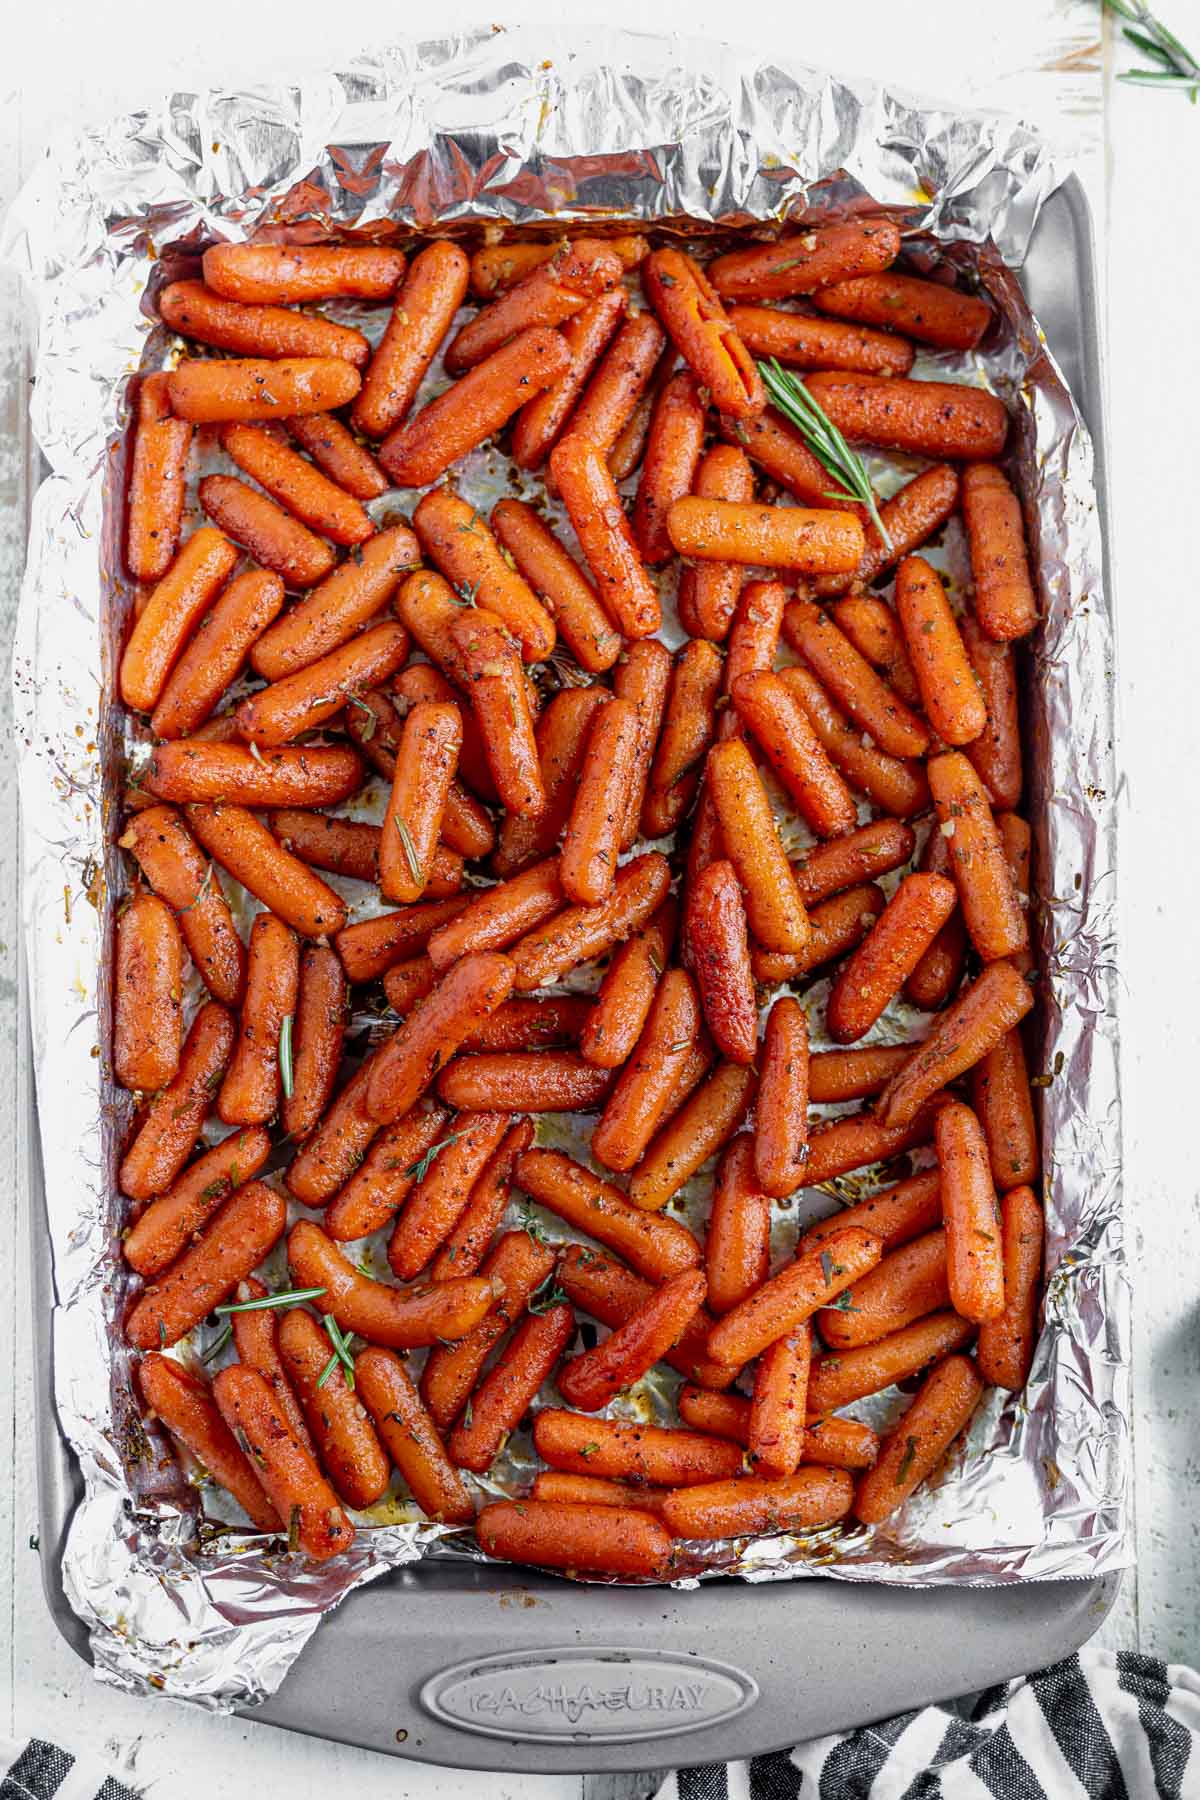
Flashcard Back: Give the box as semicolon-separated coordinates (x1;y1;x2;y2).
250;526;421;680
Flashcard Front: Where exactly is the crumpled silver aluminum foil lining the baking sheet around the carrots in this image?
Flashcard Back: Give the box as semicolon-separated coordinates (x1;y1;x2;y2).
0;27;1130;1708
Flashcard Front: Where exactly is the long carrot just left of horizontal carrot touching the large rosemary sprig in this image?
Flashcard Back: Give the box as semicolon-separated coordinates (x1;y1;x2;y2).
551;427;662;637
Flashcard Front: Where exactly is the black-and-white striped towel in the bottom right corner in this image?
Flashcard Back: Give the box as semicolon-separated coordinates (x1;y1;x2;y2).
662;1651;1200;1800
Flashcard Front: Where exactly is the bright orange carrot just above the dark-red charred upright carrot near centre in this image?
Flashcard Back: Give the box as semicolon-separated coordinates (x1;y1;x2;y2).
705;738;811;954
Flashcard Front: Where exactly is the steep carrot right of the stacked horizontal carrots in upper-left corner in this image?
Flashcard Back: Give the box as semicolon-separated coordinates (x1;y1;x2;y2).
351;241;468;437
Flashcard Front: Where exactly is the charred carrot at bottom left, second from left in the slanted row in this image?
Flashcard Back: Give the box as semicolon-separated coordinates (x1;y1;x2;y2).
212;1363;354;1562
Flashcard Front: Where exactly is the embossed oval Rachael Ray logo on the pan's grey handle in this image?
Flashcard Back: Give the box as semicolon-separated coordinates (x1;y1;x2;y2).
421;1647;759;1742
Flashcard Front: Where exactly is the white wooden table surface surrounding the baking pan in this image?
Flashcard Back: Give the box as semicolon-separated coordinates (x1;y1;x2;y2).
0;0;1200;1800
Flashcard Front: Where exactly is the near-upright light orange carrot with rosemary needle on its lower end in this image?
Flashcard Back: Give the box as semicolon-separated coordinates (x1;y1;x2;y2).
380;700;462;902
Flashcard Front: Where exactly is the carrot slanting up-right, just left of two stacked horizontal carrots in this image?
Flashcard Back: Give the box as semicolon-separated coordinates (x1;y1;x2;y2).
367;952;515;1125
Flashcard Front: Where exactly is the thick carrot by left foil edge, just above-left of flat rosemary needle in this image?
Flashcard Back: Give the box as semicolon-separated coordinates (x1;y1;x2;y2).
126;1181;288;1350
